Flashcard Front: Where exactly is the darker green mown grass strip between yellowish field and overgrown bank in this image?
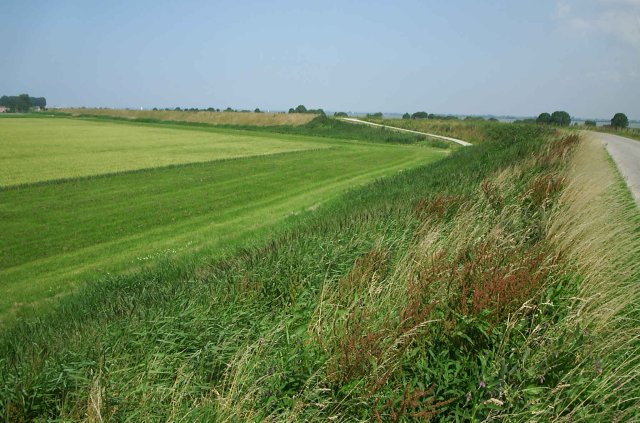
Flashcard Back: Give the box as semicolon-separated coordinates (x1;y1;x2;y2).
0;144;442;322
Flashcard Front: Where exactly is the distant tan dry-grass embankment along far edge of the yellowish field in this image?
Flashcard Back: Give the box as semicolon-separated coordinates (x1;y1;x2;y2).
56;108;317;126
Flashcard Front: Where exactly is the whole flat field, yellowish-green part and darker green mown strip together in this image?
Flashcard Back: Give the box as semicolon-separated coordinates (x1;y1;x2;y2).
0;118;443;317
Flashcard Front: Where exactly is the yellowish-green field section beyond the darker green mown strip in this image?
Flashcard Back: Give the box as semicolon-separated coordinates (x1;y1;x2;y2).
0;117;327;186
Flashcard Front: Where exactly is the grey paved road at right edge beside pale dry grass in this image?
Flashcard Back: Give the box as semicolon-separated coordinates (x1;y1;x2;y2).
590;132;640;205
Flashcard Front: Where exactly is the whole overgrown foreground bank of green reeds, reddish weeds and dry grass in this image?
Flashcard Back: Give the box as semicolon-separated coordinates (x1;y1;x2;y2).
0;126;640;421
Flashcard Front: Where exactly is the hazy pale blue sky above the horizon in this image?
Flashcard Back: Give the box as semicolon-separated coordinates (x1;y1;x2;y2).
0;0;640;119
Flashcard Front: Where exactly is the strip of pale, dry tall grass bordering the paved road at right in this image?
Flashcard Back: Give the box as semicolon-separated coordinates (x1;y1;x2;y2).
528;135;640;421
